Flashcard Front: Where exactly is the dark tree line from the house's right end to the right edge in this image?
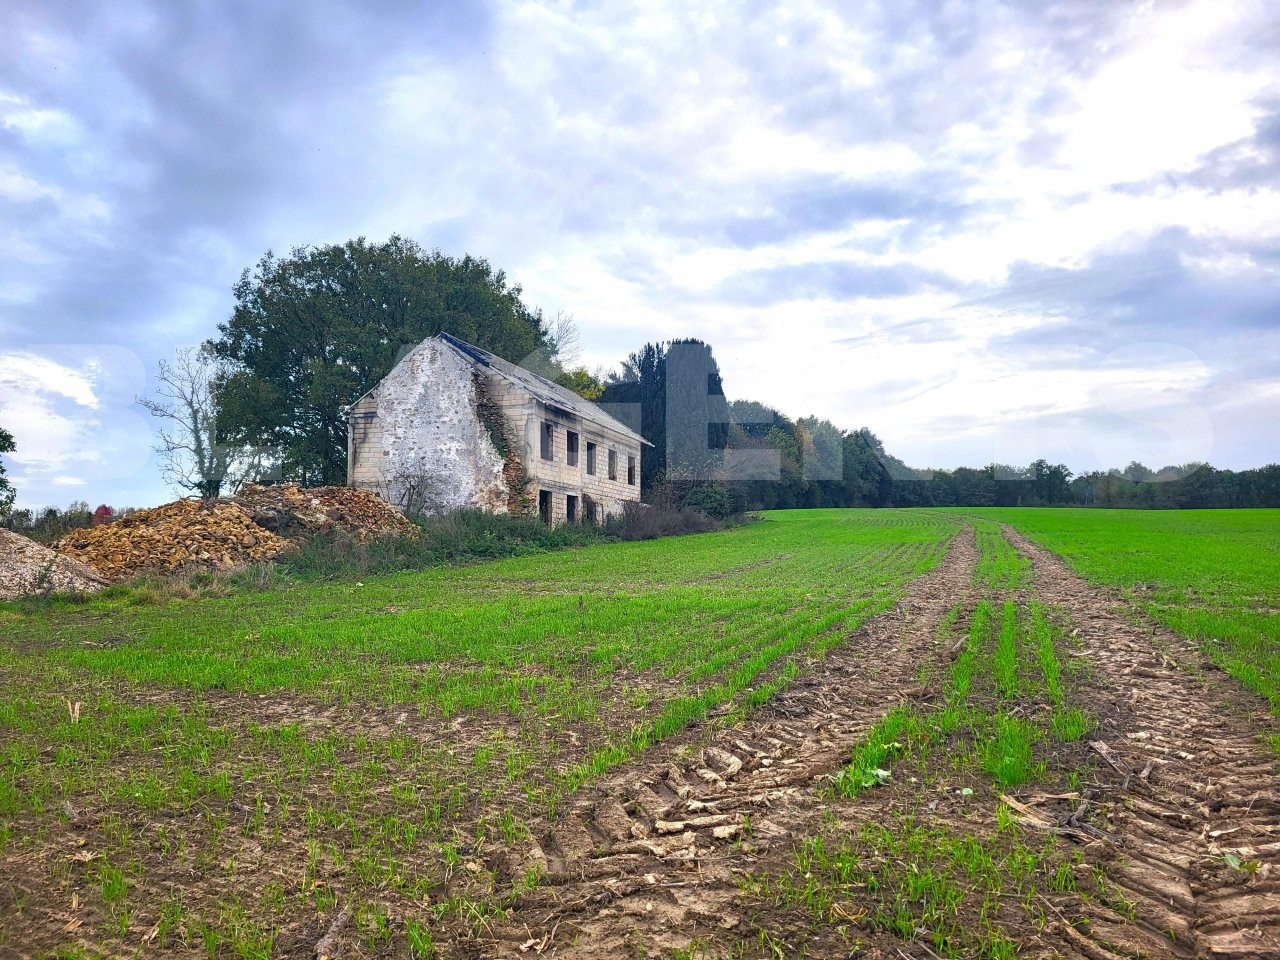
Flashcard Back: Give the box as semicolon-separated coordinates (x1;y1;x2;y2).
602;340;1280;509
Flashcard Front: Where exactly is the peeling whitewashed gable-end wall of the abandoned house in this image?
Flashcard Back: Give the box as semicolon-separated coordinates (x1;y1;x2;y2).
363;340;509;513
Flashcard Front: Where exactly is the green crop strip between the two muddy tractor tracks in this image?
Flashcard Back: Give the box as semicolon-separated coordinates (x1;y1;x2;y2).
742;547;1100;960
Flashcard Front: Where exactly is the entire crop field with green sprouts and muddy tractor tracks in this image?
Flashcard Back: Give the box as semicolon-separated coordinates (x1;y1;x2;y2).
0;509;1280;959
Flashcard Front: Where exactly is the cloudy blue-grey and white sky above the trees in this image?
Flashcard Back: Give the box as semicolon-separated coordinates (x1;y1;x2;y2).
0;0;1280;506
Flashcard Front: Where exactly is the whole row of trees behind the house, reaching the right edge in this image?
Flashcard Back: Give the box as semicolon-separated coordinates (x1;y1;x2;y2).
0;236;1280;525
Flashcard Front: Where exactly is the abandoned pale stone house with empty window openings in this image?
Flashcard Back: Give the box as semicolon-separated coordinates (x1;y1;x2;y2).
347;333;648;525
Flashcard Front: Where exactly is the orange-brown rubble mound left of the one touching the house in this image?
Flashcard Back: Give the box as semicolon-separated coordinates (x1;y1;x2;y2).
54;499;289;580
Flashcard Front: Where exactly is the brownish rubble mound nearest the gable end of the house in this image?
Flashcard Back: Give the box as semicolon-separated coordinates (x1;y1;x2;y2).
232;484;417;540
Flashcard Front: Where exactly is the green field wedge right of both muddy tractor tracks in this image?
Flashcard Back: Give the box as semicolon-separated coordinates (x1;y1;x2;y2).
964;508;1280;714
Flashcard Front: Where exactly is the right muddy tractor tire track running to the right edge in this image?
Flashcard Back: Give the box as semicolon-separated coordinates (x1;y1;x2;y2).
1005;527;1280;960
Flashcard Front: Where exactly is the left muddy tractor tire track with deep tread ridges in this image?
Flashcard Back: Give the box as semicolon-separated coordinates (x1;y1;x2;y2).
475;527;977;957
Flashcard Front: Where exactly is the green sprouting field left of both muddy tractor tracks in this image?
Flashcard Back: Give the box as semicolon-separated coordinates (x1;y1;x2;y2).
0;511;959;956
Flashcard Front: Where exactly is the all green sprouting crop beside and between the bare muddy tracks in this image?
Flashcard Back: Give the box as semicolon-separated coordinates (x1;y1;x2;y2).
0;509;1280;960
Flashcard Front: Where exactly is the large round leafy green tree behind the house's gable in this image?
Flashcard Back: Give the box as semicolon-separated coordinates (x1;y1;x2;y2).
210;237;556;485
